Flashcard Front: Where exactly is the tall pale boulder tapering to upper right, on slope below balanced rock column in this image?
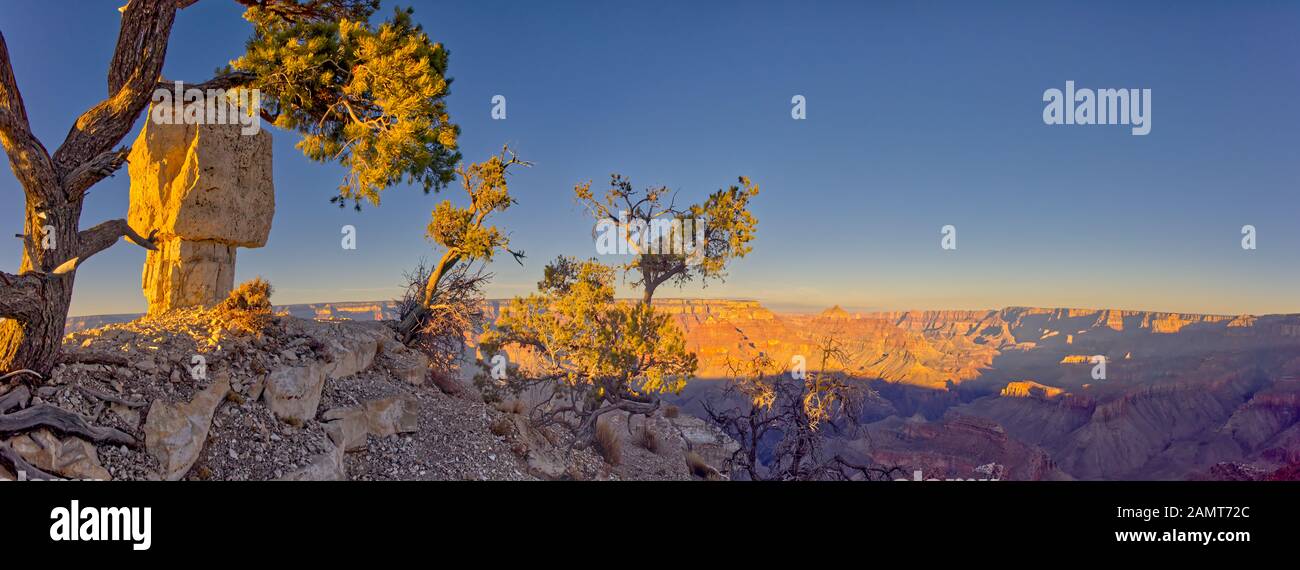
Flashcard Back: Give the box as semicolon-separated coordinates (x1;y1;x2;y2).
144;375;230;482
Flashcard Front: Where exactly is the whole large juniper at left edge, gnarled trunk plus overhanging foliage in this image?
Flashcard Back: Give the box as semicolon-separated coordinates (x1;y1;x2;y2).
0;0;460;379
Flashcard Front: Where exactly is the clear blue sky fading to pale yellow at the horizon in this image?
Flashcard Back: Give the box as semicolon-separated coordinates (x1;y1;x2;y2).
0;0;1300;314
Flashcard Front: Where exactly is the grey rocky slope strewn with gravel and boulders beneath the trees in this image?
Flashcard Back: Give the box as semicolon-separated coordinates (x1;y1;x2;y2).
0;310;735;480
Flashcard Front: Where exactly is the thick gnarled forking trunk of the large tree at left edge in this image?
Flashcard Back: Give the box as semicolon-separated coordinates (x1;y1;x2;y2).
0;0;183;376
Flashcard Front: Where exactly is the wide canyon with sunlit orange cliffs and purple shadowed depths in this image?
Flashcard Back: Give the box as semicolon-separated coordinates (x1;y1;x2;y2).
69;299;1300;480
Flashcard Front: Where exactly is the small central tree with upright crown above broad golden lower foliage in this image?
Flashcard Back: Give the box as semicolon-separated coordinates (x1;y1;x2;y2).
478;174;758;446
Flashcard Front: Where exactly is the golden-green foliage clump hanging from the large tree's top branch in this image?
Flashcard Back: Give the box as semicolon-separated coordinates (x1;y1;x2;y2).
228;3;460;208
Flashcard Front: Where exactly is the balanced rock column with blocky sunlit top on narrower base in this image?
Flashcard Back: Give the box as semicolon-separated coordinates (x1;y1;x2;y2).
127;96;276;315
